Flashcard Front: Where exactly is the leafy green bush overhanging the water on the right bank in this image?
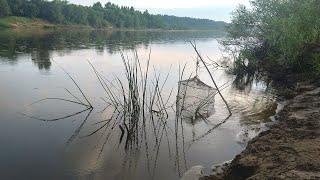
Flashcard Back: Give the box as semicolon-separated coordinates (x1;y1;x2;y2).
222;0;320;72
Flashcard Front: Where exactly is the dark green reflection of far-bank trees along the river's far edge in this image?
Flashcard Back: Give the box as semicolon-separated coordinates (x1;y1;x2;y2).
0;30;223;70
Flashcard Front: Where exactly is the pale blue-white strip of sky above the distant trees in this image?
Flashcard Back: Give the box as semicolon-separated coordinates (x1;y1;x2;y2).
69;0;249;22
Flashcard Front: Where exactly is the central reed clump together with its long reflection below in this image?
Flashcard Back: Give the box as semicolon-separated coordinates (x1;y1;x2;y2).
87;53;180;177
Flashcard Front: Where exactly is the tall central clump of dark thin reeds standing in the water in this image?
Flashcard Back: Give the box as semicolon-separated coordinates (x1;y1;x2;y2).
88;51;169;148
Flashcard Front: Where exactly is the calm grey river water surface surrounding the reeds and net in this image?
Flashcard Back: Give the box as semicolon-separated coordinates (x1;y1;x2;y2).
0;31;275;179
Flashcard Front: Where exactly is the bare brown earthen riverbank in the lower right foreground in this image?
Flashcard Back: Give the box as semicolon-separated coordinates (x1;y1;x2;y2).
204;85;320;180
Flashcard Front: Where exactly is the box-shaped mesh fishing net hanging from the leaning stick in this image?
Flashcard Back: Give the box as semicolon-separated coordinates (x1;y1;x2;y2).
177;76;217;120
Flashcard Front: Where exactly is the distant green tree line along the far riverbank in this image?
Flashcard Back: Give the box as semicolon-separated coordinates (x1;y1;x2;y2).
0;0;225;29
